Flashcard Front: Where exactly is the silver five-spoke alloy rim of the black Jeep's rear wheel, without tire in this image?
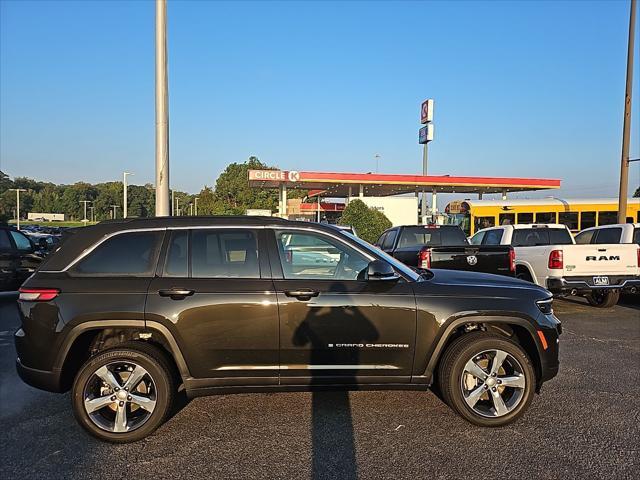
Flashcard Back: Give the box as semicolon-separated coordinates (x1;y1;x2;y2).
83;361;157;433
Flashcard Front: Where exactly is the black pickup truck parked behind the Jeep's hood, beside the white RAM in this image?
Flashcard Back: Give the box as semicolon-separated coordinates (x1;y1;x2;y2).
375;225;515;277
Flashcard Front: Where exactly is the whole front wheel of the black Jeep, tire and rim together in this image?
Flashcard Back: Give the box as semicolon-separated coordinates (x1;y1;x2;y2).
438;332;536;427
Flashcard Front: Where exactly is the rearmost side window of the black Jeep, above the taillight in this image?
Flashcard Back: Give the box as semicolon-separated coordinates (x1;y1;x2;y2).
74;232;161;276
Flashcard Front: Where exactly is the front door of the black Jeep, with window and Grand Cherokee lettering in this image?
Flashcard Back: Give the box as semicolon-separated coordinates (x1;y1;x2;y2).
270;230;416;384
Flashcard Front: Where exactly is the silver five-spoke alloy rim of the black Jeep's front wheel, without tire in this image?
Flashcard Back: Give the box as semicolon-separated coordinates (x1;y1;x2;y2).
460;349;527;418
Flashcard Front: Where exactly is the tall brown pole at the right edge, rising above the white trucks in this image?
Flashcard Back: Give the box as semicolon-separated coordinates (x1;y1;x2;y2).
618;0;636;223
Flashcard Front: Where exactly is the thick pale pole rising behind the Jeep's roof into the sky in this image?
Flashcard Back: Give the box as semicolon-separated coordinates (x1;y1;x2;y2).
156;0;169;217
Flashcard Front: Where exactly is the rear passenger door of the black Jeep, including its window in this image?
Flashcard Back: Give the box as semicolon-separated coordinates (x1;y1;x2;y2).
145;229;279;385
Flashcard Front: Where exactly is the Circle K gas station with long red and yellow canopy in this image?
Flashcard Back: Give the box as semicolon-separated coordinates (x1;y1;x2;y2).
249;170;560;224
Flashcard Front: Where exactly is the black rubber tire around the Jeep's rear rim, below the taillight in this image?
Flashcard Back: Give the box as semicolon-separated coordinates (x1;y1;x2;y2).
71;342;177;443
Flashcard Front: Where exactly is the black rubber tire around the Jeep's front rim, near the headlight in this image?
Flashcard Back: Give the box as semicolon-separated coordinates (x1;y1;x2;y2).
438;332;536;427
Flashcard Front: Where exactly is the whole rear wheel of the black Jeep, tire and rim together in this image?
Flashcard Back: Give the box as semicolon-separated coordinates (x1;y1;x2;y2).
72;342;176;443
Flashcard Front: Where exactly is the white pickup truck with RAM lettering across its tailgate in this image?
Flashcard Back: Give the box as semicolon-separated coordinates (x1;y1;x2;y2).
471;224;640;307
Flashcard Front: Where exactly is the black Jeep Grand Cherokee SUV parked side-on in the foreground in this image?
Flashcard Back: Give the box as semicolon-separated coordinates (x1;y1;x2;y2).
15;217;560;442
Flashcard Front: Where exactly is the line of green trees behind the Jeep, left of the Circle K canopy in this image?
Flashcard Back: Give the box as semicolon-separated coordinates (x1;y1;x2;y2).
0;157;306;221
